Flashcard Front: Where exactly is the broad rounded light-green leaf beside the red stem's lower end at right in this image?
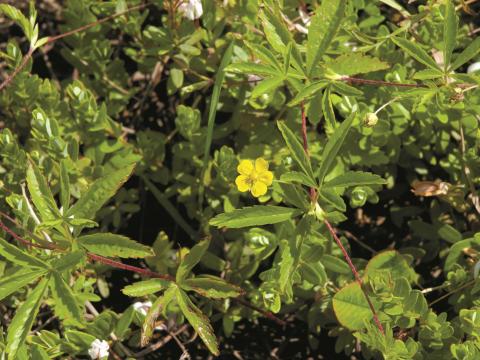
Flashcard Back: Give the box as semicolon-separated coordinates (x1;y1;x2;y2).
333;282;378;331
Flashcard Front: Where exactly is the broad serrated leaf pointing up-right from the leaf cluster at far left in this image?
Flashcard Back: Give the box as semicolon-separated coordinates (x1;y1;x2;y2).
65;164;135;219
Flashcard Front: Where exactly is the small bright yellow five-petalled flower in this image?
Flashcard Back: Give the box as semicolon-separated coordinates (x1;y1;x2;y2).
235;158;273;197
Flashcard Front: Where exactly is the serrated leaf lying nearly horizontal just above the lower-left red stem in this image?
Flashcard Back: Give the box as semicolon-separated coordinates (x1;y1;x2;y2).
77;233;153;258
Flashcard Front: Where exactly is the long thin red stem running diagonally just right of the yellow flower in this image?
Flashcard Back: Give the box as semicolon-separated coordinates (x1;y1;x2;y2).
300;102;385;335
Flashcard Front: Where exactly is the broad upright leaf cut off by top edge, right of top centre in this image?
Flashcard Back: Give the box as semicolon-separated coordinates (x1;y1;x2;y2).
307;0;346;76
